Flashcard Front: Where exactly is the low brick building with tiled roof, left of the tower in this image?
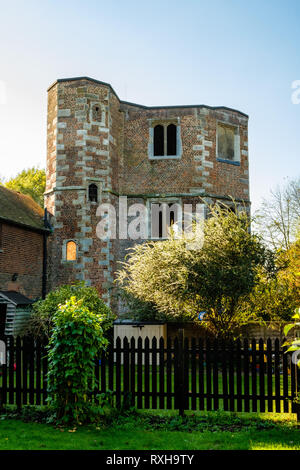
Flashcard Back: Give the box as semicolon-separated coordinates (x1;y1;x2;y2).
0;186;49;299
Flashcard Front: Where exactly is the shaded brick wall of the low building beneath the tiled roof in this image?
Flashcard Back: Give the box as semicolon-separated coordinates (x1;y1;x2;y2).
0;223;43;299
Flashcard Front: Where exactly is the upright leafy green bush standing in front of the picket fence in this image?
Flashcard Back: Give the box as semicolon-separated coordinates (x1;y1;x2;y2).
47;297;108;424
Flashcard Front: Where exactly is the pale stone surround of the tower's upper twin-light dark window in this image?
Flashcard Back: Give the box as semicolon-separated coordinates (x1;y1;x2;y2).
148;117;182;160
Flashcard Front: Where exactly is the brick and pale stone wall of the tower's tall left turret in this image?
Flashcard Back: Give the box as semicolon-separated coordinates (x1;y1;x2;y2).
45;80;123;301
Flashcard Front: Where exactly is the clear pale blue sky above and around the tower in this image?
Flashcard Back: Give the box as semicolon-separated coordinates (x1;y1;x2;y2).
0;0;300;210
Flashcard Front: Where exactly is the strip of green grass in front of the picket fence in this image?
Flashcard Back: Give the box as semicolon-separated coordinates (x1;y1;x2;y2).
0;411;300;450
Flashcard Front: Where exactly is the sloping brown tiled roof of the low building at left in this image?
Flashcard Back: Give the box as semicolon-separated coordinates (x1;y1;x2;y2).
0;185;45;230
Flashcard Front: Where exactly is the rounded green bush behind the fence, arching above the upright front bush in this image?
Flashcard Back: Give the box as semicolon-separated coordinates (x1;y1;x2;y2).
23;282;115;339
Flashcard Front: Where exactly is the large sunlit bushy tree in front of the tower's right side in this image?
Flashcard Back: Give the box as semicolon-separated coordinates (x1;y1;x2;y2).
117;205;268;337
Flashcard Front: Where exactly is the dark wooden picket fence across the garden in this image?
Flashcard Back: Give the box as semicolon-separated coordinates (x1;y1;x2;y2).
0;331;300;415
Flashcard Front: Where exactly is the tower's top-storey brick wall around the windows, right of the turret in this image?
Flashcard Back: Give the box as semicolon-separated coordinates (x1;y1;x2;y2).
120;104;249;200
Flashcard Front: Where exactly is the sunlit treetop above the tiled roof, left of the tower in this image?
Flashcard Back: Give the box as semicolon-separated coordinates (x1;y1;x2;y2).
3;167;46;207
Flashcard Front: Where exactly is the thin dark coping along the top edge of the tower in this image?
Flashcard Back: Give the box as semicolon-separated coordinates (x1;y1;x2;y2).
47;77;249;118
